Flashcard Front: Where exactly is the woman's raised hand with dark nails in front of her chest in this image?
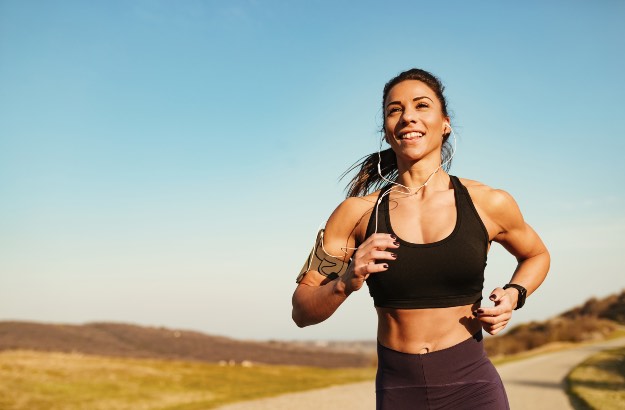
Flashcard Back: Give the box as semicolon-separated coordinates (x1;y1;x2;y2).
341;233;399;295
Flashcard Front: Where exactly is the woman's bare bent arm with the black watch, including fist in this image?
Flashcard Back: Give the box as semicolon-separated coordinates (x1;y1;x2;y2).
476;189;550;335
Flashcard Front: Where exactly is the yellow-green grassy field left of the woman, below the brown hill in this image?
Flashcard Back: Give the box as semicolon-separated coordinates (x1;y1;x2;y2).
0;351;375;410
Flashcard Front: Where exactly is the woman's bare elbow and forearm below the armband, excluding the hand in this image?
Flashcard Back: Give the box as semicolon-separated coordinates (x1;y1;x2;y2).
292;279;349;327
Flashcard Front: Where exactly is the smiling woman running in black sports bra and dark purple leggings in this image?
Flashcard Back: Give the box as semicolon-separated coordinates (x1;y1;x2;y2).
293;69;550;410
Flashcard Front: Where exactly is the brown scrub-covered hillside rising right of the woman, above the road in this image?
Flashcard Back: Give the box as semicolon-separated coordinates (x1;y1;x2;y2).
485;291;625;357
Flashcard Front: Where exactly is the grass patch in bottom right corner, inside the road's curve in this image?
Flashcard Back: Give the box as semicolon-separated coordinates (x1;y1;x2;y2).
567;347;625;410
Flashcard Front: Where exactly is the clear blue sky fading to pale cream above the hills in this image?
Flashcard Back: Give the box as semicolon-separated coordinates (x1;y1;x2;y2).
0;0;625;340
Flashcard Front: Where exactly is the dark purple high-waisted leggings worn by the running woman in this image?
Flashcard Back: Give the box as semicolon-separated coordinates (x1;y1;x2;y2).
375;332;510;410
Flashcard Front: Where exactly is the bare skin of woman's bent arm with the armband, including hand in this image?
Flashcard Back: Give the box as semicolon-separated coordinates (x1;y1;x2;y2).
292;198;398;327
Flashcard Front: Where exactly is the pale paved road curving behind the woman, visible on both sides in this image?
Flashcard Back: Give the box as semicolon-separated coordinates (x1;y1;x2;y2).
219;338;625;410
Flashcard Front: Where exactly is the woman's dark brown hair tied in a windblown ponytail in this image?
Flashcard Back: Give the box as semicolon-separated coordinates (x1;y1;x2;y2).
341;68;452;197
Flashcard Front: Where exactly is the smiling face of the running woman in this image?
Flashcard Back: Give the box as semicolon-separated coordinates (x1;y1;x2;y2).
384;80;449;161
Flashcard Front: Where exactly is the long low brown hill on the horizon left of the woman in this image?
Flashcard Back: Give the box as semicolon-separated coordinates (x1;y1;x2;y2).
0;322;372;368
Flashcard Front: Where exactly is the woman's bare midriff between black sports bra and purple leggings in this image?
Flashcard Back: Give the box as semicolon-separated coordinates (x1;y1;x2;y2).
376;302;481;354
